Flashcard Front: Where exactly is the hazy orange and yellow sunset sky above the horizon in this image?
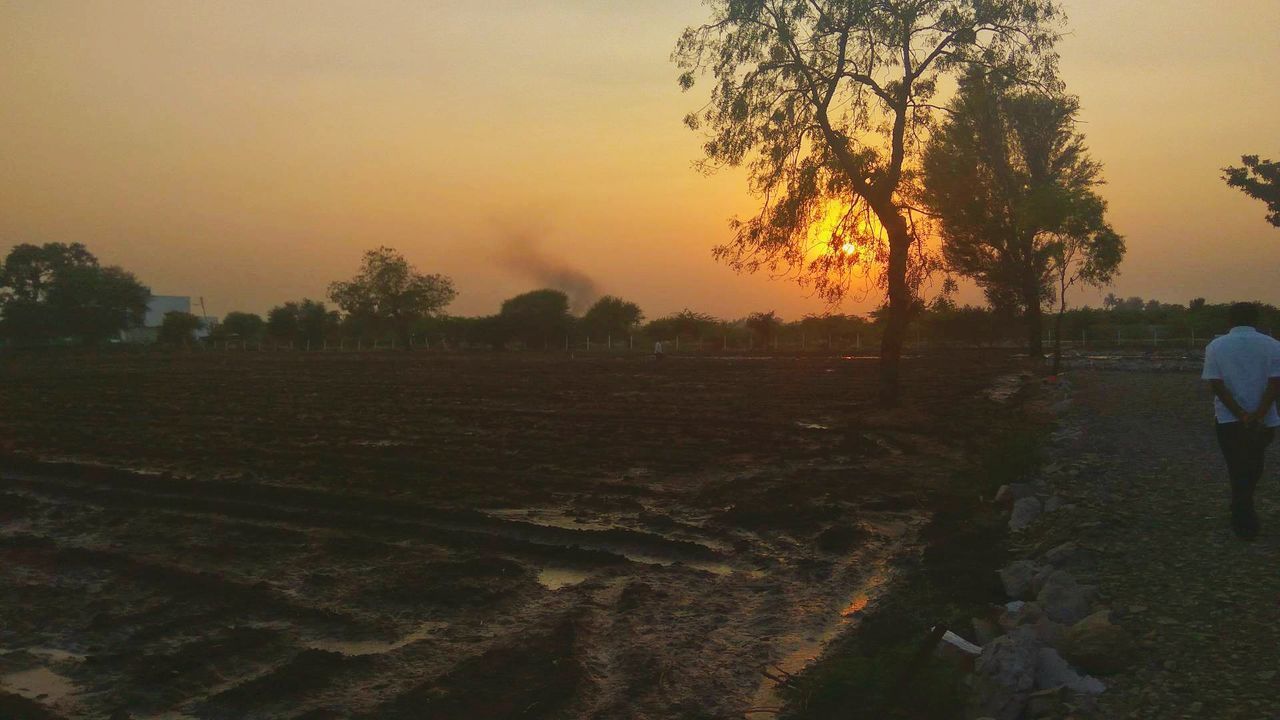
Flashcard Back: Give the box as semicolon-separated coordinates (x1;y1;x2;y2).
0;0;1280;319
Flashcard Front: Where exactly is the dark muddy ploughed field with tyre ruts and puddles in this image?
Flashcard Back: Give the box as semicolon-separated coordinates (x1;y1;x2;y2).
0;352;1011;720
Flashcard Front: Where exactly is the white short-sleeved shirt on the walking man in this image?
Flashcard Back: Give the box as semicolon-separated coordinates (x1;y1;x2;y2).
1201;325;1280;428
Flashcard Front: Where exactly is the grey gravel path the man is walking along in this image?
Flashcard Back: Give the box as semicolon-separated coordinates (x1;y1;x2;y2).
1059;372;1280;720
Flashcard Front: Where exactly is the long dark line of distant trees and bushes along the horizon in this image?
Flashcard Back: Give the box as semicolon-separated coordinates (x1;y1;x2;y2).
0;243;1280;351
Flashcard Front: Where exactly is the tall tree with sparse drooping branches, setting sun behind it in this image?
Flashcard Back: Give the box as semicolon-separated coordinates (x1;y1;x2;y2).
675;0;1060;402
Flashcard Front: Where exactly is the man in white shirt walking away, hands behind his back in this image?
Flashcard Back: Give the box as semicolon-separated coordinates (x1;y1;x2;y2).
1201;302;1280;539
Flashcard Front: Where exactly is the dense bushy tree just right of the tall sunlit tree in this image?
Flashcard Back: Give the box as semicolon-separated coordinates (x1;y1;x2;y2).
923;69;1124;359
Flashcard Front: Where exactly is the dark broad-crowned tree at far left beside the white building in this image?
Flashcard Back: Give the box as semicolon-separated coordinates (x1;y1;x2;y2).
0;242;151;343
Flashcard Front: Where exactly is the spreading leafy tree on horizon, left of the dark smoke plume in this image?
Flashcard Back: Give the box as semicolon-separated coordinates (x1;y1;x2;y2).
329;247;458;350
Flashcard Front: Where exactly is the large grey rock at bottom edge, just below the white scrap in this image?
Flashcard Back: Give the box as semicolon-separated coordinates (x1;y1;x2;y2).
973;628;1039;720
